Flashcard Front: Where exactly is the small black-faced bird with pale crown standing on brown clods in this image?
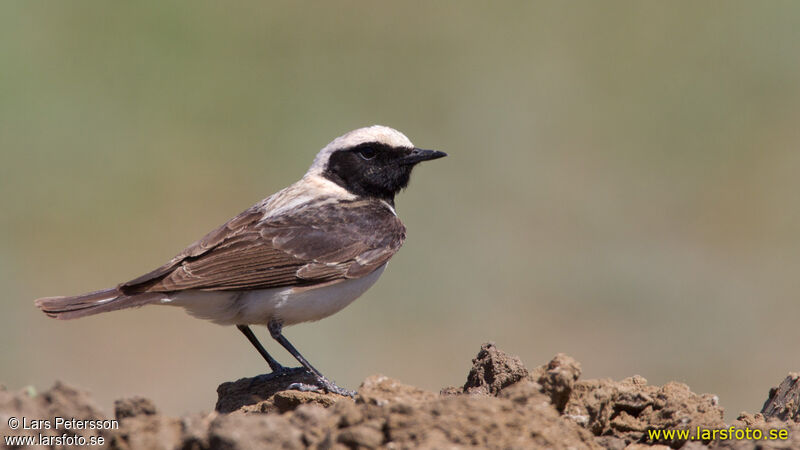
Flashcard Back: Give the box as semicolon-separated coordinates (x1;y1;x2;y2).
35;125;447;396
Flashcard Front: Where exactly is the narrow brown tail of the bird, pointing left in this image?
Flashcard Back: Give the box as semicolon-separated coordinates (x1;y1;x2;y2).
36;288;165;320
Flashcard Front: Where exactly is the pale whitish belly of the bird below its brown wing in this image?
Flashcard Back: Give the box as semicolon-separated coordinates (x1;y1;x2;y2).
161;264;386;326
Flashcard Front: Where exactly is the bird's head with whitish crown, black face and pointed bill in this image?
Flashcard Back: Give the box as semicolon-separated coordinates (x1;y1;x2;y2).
309;125;447;203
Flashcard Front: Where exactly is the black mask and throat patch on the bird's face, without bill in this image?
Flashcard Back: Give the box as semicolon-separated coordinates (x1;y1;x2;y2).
323;143;414;206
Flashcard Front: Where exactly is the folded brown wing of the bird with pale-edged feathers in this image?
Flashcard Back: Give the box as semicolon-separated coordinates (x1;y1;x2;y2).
120;201;405;294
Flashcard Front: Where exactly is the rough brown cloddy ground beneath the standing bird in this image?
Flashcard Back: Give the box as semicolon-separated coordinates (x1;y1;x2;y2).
0;344;800;450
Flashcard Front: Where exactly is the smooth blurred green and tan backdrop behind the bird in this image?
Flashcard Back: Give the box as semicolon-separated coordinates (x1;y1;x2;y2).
0;1;800;419
